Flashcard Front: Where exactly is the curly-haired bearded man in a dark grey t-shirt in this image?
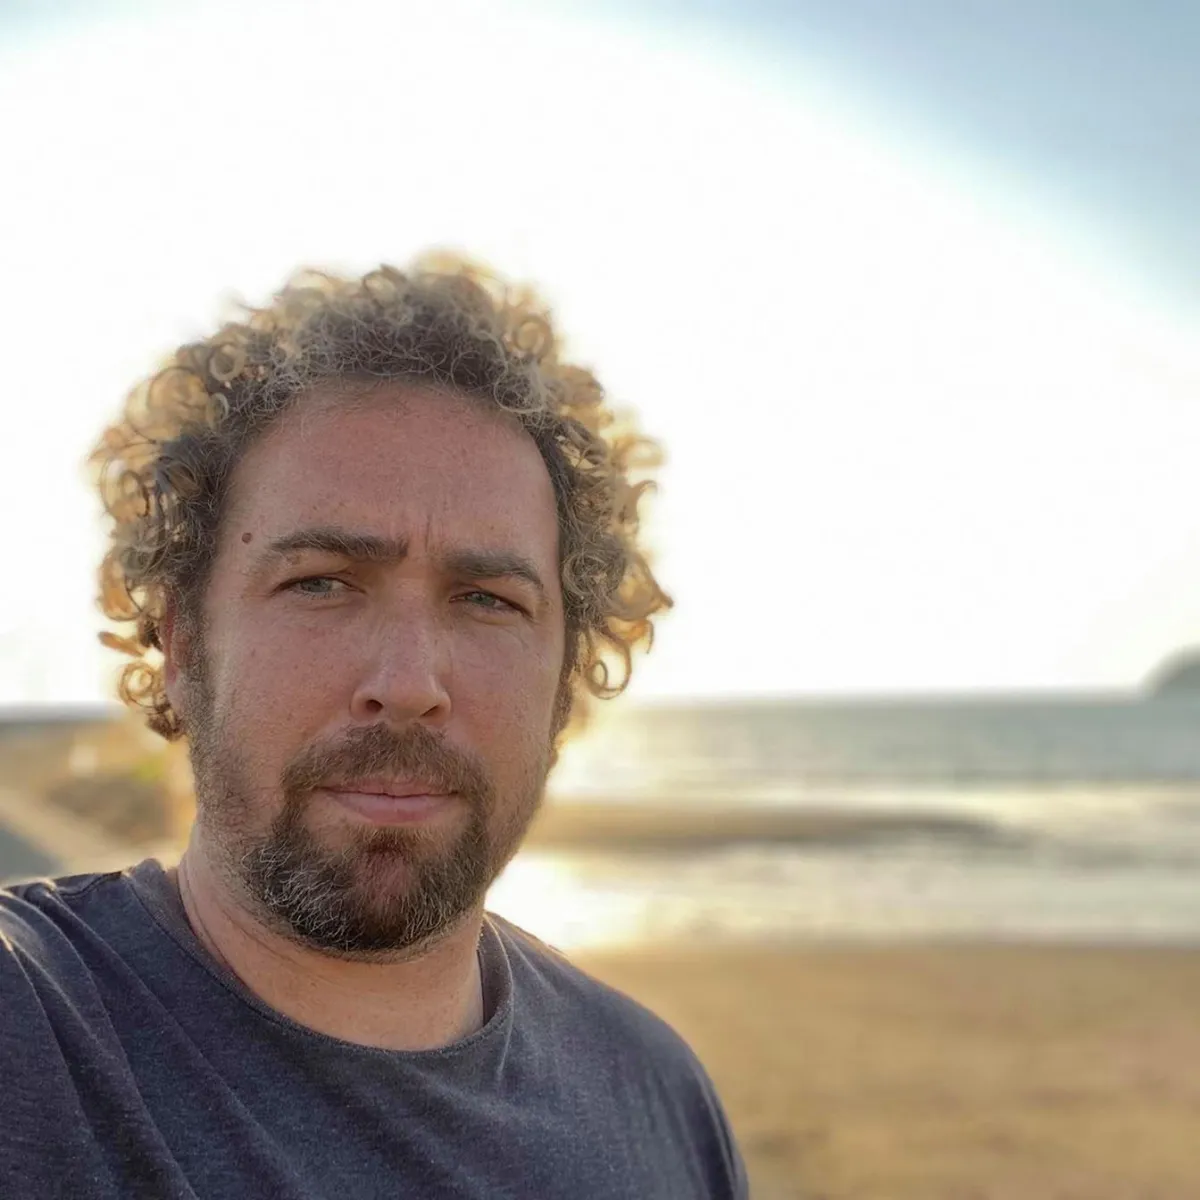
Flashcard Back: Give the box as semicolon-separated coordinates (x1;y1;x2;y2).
0;260;746;1200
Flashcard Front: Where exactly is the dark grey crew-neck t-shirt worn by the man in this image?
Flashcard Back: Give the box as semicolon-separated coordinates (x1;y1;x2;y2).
0;859;748;1200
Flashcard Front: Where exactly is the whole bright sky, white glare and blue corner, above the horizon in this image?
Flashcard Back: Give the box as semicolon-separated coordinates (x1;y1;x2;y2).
0;0;1200;703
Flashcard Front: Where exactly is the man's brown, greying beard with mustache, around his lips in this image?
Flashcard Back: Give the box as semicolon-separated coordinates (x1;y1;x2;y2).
188;685;552;959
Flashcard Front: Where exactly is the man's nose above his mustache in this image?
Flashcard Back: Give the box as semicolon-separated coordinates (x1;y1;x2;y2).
350;611;450;725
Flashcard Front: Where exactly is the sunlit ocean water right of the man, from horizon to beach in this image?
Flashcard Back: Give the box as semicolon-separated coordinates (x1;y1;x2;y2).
490;695;1200;949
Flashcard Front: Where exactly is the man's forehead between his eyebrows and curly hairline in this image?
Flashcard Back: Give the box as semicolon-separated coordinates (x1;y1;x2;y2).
228;384;558;552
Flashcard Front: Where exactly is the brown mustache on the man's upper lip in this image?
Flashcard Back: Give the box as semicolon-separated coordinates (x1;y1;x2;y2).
281;725;492;805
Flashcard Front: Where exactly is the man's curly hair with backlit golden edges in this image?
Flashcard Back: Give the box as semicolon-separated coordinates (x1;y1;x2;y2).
89;254;671;740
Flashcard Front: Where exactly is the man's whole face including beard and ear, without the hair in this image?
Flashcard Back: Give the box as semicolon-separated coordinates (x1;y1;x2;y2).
167;385;564;956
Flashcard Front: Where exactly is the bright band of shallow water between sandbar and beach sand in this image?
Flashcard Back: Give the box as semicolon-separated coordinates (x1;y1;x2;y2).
488;842;1200;952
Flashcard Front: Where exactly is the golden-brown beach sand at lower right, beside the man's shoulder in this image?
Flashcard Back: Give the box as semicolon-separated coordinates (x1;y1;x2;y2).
576;946;1200;1200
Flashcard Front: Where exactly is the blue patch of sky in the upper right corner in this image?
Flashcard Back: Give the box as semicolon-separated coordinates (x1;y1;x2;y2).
657;0;1200;311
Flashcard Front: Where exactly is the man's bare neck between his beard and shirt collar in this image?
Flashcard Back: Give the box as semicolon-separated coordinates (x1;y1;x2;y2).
170;836;484;1050
